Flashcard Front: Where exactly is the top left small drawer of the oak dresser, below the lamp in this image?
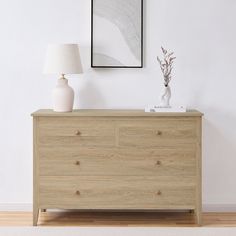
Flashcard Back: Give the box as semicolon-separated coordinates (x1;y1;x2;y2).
37;117;115;147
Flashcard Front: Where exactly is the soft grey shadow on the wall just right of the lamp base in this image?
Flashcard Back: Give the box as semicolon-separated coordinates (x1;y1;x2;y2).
76;79;106;109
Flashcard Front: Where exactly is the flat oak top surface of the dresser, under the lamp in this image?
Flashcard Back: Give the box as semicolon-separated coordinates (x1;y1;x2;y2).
31;109;203;117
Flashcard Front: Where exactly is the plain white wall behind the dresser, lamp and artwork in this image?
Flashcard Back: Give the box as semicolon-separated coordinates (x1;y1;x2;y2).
0;0;236;210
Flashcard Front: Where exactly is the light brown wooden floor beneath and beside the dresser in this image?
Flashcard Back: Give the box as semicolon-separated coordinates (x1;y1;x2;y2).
0;212;236;227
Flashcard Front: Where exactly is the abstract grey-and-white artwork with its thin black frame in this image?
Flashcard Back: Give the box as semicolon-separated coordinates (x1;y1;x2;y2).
91;0;143;68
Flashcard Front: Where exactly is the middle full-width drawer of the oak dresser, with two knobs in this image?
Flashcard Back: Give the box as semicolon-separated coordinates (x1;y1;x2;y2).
38;147;196;176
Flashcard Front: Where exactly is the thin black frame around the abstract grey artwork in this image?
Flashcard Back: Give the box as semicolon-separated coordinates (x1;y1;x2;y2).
91;0;144;69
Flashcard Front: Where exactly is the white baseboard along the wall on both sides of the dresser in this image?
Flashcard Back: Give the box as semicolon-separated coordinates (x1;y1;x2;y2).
0;203;236;212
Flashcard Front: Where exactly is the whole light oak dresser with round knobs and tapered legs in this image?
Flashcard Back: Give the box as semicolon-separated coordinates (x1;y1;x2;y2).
32;110;202;225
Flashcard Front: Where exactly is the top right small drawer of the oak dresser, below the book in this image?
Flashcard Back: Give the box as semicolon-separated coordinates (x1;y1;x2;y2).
119;117;197;148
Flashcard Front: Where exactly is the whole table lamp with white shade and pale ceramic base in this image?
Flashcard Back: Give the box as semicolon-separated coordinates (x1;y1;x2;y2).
44;44;83;112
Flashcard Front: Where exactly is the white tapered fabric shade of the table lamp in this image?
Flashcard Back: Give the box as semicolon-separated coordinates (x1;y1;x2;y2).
43;44;83;74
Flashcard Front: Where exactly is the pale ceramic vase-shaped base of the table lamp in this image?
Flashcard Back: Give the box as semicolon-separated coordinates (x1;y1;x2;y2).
52;79;74;112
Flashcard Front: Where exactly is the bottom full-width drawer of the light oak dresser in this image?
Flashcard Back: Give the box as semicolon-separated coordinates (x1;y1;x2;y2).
38;176;195;210
